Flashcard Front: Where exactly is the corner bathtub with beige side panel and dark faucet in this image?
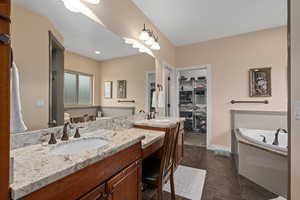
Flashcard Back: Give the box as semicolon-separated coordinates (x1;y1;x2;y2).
233;128;288;197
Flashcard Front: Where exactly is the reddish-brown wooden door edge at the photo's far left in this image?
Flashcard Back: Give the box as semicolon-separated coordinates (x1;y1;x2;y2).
0;0;11;200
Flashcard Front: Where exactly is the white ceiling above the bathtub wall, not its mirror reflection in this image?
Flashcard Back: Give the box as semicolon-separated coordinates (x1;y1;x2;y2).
132;0;287;46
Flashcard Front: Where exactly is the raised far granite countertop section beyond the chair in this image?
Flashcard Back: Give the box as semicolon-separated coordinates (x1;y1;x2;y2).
133;118;185;128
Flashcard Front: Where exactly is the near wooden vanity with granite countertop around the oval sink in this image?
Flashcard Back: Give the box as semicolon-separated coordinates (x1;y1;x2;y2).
11;128;164;200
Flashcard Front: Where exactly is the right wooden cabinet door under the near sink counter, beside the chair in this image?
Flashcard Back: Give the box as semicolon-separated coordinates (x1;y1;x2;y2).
107;161;142;200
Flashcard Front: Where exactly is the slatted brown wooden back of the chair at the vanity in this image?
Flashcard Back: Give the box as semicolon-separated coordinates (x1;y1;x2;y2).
160;123;180;181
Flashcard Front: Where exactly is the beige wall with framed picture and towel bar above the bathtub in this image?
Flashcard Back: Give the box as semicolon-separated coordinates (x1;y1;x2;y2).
176;27;287;147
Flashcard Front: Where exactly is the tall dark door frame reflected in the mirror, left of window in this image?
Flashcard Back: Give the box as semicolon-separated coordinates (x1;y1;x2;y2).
49;32;64;127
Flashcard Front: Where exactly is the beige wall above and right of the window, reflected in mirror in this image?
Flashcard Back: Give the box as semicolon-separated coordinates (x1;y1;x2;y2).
65;51;101;105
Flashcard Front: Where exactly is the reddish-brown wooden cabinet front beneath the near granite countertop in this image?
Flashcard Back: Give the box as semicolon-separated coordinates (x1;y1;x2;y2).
21;142;142;200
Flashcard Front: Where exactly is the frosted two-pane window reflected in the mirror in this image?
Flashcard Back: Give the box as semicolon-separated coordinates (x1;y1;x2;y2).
64;71;93;105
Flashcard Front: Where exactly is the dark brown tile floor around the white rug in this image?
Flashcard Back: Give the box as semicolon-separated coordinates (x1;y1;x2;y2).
143;145;276;200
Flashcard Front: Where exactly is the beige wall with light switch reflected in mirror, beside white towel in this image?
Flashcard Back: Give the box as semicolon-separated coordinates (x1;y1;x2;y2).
11;3;63;130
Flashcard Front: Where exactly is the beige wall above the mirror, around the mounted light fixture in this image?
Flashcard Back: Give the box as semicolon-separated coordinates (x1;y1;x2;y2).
86;0;175;66
